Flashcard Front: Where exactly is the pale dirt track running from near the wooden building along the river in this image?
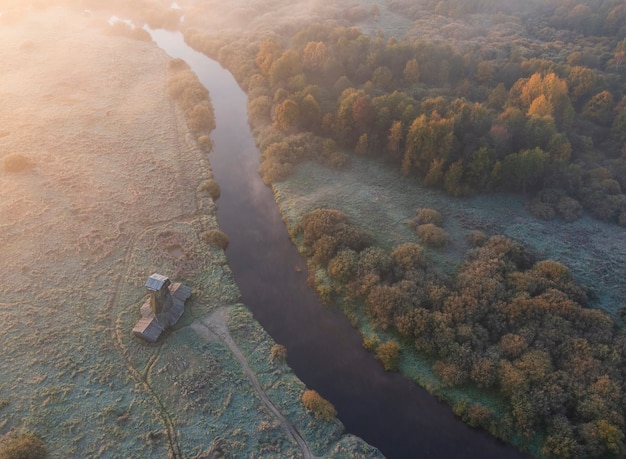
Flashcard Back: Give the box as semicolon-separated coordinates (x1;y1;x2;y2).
191;307;316;459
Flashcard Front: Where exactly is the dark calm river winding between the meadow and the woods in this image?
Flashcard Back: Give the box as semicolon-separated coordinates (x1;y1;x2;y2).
151;30;524;459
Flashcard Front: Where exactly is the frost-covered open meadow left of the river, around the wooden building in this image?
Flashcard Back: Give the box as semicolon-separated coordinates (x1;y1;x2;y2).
0;7;378;458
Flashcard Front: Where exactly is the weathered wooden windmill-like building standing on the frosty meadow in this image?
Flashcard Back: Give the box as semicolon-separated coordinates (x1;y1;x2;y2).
133;273;191;343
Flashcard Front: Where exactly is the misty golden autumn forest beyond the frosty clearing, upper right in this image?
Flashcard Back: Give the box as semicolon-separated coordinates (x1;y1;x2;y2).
186;1;626;225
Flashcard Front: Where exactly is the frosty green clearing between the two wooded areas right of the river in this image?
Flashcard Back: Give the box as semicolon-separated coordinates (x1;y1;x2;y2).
274;157;626;317
